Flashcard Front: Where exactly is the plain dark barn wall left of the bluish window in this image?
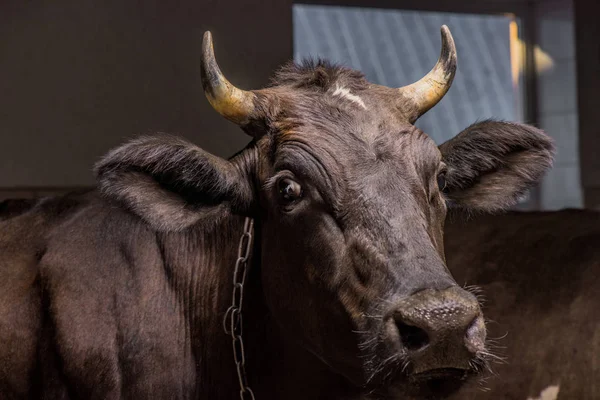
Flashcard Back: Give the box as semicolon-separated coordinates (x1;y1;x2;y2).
0;0;292;197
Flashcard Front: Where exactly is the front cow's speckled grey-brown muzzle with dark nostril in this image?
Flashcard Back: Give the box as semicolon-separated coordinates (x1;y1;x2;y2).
388;286;486;380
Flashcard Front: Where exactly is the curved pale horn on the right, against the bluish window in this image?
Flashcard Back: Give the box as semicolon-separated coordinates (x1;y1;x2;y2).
399;25;456;123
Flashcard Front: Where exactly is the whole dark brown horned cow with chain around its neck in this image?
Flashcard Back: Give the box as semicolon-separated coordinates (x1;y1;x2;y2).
0;26;554;400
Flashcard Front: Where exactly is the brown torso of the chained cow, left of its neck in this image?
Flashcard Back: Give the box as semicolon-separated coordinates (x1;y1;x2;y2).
0;194;206;399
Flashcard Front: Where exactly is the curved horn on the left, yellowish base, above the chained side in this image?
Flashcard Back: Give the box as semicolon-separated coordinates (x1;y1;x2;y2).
201;31;255;125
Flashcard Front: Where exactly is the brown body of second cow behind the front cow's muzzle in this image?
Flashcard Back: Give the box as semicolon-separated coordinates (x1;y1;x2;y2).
444;209;600;400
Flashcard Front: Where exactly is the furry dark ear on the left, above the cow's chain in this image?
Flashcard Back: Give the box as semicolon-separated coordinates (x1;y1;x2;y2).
95;135;253;231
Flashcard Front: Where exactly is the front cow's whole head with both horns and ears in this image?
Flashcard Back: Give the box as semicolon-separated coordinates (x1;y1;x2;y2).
97;27;553;392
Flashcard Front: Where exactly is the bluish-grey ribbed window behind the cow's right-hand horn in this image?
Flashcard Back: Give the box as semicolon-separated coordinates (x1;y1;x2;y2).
293;4;524;143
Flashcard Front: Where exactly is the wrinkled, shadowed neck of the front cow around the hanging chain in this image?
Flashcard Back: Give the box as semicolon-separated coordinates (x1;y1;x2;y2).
161;215;353;400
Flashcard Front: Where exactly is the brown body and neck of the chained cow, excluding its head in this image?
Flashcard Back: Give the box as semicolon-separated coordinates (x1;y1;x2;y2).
0;192;359;399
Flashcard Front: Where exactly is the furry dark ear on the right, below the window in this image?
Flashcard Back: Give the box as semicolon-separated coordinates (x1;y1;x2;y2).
440;121;554;211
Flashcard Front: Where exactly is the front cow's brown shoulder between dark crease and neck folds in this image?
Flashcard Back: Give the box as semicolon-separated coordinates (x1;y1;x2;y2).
40;196;194;398
